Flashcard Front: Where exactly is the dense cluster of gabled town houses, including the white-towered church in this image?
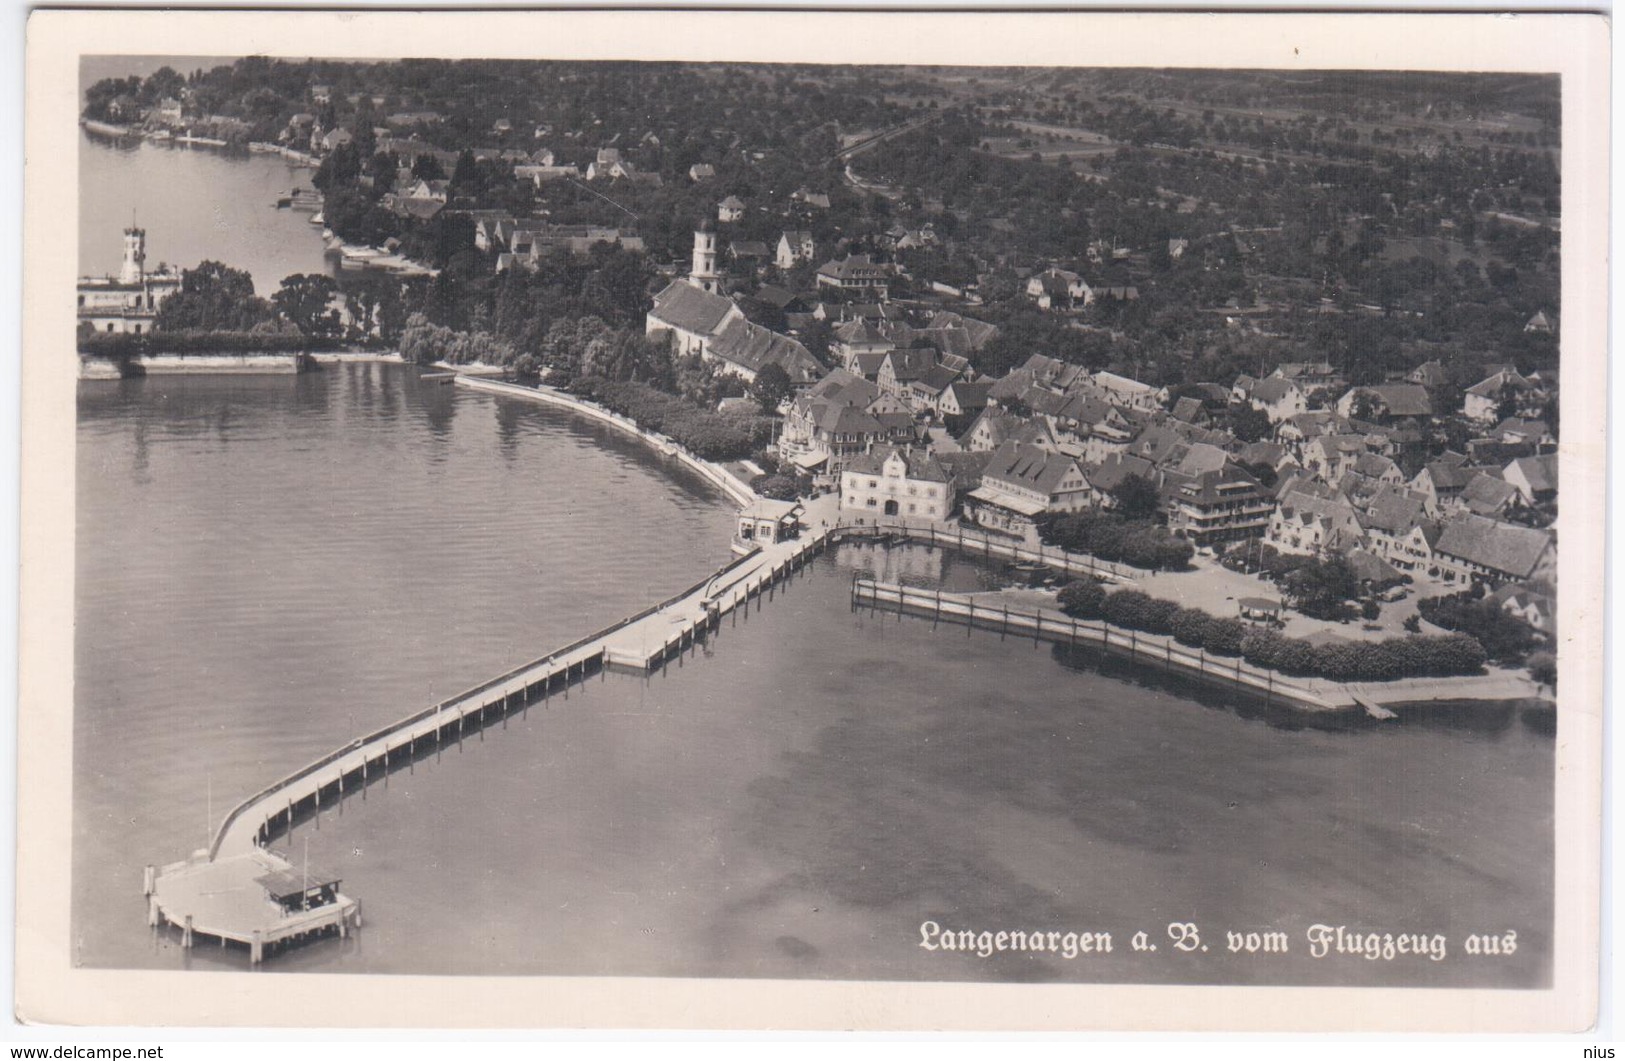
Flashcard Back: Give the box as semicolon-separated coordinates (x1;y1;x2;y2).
647;212;1557;632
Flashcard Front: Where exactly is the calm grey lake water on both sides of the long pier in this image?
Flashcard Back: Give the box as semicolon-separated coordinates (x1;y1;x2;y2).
73;138;1554;986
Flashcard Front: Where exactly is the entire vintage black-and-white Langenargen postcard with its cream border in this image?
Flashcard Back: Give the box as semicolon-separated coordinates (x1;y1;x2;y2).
23;13;1602;1025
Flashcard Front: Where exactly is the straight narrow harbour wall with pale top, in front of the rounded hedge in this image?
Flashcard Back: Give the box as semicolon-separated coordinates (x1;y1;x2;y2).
852;577;1341;710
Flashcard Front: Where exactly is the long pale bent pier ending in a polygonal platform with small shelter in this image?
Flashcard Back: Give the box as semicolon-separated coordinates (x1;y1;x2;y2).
143;519;840;962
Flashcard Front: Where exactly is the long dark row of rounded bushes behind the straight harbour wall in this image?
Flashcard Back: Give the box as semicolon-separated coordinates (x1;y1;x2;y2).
1056;580;1485;681
